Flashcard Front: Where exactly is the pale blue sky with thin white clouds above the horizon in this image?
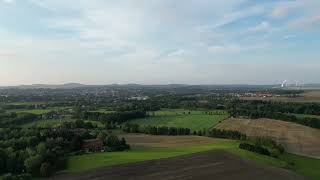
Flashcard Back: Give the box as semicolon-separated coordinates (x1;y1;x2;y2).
0;0;320;86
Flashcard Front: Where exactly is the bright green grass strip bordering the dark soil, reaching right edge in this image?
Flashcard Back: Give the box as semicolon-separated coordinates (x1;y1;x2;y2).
66;141;320;180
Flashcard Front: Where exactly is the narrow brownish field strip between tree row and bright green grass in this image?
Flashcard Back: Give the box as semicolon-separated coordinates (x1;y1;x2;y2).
120;134;232;148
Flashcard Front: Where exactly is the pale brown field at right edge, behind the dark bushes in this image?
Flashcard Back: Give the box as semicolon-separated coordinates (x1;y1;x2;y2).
215;118;320;158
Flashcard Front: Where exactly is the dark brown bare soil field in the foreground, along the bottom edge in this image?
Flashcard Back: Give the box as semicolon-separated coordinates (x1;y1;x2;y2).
52;151;303;180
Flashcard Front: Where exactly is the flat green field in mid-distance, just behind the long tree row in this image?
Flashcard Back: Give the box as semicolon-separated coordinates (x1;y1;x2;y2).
130;109;229;131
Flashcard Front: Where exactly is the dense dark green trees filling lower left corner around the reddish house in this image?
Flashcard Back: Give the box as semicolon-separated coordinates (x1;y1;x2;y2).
0;128;130;179
